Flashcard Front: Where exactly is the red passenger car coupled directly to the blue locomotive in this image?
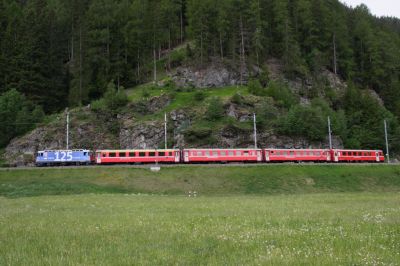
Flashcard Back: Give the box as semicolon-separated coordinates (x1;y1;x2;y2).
96;150;181;164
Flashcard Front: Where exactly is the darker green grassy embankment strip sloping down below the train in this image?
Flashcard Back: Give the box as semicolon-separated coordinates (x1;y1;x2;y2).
0;165;400;198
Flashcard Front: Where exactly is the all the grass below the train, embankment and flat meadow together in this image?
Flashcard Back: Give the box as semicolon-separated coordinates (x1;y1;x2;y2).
0;165;400;265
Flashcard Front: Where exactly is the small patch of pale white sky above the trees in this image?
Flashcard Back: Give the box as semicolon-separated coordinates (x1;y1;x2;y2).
341;0;400;18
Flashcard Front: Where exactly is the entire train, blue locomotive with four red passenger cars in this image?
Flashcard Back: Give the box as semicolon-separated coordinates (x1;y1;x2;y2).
35;148;385;166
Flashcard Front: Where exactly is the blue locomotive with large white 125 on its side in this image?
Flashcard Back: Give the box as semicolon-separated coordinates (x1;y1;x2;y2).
36;150;93;166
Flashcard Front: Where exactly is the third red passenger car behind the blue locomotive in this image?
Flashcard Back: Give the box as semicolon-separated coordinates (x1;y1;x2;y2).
264;149;331;162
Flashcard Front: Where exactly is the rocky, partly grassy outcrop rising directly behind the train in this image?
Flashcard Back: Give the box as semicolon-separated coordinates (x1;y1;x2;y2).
4;60;347;165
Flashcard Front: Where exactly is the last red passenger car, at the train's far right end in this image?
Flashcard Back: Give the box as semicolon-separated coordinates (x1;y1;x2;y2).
331;149;385;163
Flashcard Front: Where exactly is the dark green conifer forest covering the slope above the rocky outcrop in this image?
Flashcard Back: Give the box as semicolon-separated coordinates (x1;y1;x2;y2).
0;0;400;152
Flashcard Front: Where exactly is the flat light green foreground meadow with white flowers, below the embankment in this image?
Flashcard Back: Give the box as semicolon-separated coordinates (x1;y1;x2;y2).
0;192;400;265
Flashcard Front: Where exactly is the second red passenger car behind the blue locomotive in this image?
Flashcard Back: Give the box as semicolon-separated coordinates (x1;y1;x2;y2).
183;149;263;163
